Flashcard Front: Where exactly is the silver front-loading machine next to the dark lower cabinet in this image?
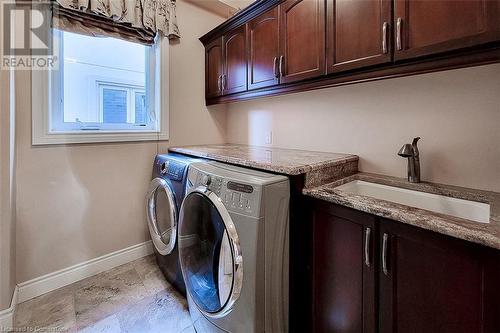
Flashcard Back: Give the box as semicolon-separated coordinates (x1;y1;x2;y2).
179;162;290;333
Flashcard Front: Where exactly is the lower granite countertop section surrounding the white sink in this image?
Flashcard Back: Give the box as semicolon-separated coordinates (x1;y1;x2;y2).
303;173;500;249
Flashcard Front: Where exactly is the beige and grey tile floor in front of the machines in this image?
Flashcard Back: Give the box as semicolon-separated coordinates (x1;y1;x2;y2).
14;256;194;333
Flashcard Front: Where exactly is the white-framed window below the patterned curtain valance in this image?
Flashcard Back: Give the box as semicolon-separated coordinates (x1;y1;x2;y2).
32;30;168;144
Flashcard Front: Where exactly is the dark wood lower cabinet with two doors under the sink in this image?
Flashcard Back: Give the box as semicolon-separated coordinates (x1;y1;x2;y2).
313;201;500;333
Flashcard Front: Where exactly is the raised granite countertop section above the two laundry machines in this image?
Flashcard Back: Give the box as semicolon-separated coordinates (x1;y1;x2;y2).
169;144;358;176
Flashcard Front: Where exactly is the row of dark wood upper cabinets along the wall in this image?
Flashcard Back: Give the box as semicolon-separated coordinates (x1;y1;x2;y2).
200;0;500;104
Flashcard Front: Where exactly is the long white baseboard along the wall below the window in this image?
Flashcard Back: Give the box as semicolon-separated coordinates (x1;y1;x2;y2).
18;241;153;303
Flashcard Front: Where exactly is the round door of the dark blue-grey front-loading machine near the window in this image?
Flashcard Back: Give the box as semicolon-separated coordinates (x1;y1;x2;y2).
146;178;177;255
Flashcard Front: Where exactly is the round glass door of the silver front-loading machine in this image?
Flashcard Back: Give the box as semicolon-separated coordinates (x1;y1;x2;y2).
179;187;243;318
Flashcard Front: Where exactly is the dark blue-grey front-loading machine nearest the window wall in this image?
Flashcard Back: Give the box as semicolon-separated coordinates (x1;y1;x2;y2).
146;153;200;295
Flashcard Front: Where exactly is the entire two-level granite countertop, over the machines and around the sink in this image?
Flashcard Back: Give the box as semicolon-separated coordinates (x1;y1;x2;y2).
169;144;500;249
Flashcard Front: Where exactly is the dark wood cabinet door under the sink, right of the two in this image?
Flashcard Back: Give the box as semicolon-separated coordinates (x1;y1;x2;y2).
379;220;483;333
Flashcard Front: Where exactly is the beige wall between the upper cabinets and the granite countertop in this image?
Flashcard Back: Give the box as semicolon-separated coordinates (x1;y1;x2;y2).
227;64;500;192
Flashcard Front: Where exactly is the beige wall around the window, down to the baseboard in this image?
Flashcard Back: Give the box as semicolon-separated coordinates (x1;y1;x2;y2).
16;0;225;282
